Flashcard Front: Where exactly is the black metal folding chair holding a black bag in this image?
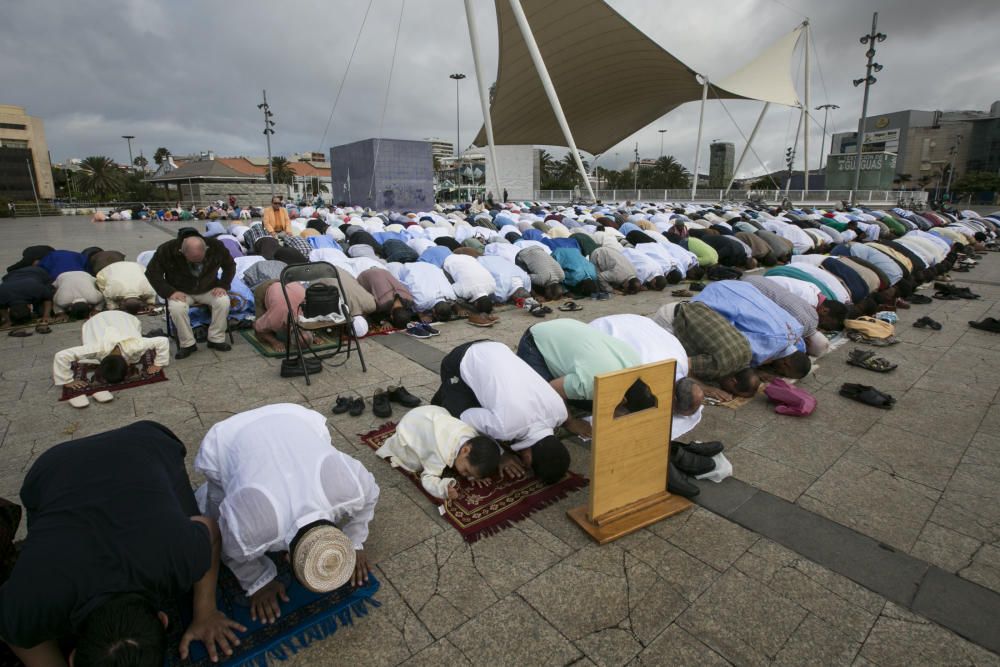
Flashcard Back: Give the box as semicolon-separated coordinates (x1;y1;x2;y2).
279;262;368;385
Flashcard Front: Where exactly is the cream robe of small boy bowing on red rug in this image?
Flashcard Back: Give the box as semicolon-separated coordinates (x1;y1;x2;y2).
375;405;479;500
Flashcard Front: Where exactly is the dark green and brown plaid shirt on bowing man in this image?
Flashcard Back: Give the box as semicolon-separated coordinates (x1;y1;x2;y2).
673;302;751;380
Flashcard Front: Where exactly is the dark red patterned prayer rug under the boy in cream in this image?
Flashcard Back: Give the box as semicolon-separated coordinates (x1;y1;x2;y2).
360;422;589;542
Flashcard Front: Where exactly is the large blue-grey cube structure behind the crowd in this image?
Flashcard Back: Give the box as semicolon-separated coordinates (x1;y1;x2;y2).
330;139;434;211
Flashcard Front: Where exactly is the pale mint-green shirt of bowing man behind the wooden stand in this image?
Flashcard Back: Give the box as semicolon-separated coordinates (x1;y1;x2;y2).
532;319;642;401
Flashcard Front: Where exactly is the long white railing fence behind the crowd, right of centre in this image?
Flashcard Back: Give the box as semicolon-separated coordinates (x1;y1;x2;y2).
535;189;928;206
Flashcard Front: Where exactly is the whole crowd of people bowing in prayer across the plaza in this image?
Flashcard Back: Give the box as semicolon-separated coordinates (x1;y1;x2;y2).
0;198;1000;667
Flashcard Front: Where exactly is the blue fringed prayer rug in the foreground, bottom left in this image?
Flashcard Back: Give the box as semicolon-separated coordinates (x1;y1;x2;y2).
165;554;381;667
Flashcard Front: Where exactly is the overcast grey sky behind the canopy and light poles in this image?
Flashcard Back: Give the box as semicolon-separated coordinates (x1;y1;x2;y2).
0;0;1000;176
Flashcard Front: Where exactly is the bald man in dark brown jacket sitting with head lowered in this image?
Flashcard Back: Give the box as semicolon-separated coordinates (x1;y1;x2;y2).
146;227;236;359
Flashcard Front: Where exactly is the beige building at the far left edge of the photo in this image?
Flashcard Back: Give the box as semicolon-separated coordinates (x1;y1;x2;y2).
0;104;56;200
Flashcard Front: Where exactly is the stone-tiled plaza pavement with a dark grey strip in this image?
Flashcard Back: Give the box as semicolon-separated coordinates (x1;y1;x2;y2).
0;217;1000;666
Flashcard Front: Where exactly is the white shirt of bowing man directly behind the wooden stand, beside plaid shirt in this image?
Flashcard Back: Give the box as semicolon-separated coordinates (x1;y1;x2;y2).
589;316;703;438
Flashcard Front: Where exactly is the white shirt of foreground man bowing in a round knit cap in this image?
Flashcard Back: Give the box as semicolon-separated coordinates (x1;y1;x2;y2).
194;403;379;595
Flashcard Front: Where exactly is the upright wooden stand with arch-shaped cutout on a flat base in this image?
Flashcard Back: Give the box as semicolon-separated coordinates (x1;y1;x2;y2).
568;359;691;544
